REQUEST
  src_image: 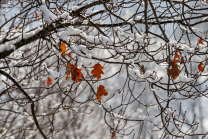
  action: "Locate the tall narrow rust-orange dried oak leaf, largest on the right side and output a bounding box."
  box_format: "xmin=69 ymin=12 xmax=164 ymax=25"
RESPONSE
xmin=167 ymin=50 xmax=181 ymax=79
